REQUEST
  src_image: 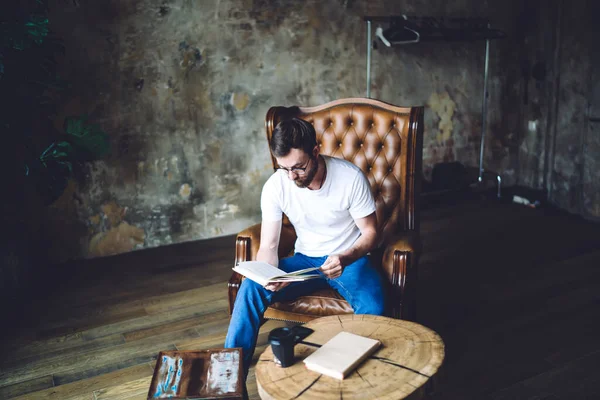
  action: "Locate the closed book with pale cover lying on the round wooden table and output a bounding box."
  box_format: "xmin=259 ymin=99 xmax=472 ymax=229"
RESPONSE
xmin=304 ymin=332 xmax=381 ymax=380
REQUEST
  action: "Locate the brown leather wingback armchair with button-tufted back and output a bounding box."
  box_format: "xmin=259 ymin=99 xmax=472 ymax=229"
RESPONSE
xmin=229 ymin=98 xmax=423 ymax=322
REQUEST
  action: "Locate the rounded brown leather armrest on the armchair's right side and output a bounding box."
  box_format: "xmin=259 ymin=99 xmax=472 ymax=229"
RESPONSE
xmin=381 ymin=231 xmax=422 ymax=321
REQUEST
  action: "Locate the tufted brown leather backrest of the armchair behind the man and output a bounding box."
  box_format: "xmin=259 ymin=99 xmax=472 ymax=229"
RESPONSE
xmin=266 ymin=98 xmax=423 ymax=245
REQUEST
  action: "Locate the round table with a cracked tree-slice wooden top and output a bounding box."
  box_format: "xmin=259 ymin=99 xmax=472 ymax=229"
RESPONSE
xmin=256 ymin=314 xmax=444 ymax=400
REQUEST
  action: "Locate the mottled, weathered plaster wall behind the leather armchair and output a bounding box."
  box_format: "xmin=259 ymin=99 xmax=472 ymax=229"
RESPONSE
xmin=38 ymin=0 xmax=596 ymax=259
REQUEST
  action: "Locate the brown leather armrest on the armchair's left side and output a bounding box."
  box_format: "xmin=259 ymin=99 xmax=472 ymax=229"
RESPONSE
xmin=227 ymin=220 xmax=296 ymax=315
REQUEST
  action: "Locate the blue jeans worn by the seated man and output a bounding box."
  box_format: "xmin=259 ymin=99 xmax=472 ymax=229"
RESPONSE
xmin=225 ymin=253 xmax=384 ymax=376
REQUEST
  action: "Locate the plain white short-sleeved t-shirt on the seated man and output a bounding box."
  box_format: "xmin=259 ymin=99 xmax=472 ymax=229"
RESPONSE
xmin=261 ymin=156 xmax=375 ymax=257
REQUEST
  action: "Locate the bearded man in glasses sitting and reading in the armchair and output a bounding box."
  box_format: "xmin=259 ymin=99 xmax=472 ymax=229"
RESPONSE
xmin=225 ymin=118 xmax=384 ymax=376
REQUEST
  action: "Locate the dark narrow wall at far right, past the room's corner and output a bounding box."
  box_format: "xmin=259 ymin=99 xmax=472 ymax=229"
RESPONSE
xmin=551 ymin=1 xmax=600 ymax=218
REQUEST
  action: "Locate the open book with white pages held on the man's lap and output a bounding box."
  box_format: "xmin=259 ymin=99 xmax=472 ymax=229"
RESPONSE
xmin=233 ymin=261 xmax=323 ymax=286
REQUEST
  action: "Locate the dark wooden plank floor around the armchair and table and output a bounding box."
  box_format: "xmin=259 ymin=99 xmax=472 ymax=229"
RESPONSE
xmin=0 ymin=200 xmax=600 ymax=400
